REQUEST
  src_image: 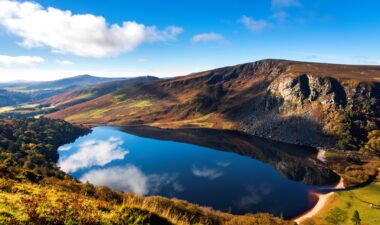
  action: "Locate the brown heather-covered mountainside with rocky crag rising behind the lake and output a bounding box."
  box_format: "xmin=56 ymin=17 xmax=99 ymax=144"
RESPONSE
xmin=47 ymin=60 xmax=380 ymax=148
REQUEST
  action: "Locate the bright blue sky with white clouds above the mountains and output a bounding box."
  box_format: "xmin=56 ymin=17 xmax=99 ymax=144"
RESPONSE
xmin=0 ymin=0 xmax=380 ymax=81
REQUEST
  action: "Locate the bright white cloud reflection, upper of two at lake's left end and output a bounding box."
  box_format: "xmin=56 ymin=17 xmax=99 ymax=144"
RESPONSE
xmin=59 ymin=137 xmax=128 ymax=173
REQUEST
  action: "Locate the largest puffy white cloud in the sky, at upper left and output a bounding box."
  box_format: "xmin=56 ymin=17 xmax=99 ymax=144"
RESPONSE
xmin=0 ymin=0 xmax=183 ymax=57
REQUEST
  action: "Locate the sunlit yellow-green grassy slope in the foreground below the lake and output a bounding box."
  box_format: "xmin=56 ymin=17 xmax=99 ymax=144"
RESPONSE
xmin=0 ymin=178 xmax=292 ymax=225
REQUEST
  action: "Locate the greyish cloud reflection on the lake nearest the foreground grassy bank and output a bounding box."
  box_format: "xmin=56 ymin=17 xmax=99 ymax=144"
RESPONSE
xmin=80 ymin=165 xmax=184 ymax=195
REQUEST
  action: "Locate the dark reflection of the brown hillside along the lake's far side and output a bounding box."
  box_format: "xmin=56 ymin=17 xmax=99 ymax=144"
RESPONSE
xmin=123 ymin=126 xmax=339 ymax=185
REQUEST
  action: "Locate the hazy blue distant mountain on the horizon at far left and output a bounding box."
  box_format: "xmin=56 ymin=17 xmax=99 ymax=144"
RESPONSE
xmin=0 ymin=75 xmax=125 ymax=106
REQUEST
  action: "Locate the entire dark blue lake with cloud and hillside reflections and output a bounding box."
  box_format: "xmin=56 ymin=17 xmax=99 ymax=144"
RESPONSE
xmin=59 ymin=127 xmax=337 ymax=218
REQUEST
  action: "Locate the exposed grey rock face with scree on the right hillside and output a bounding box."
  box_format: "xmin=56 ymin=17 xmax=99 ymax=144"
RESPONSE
xmin=240 ymin=69 xmax=379 ymax=147
